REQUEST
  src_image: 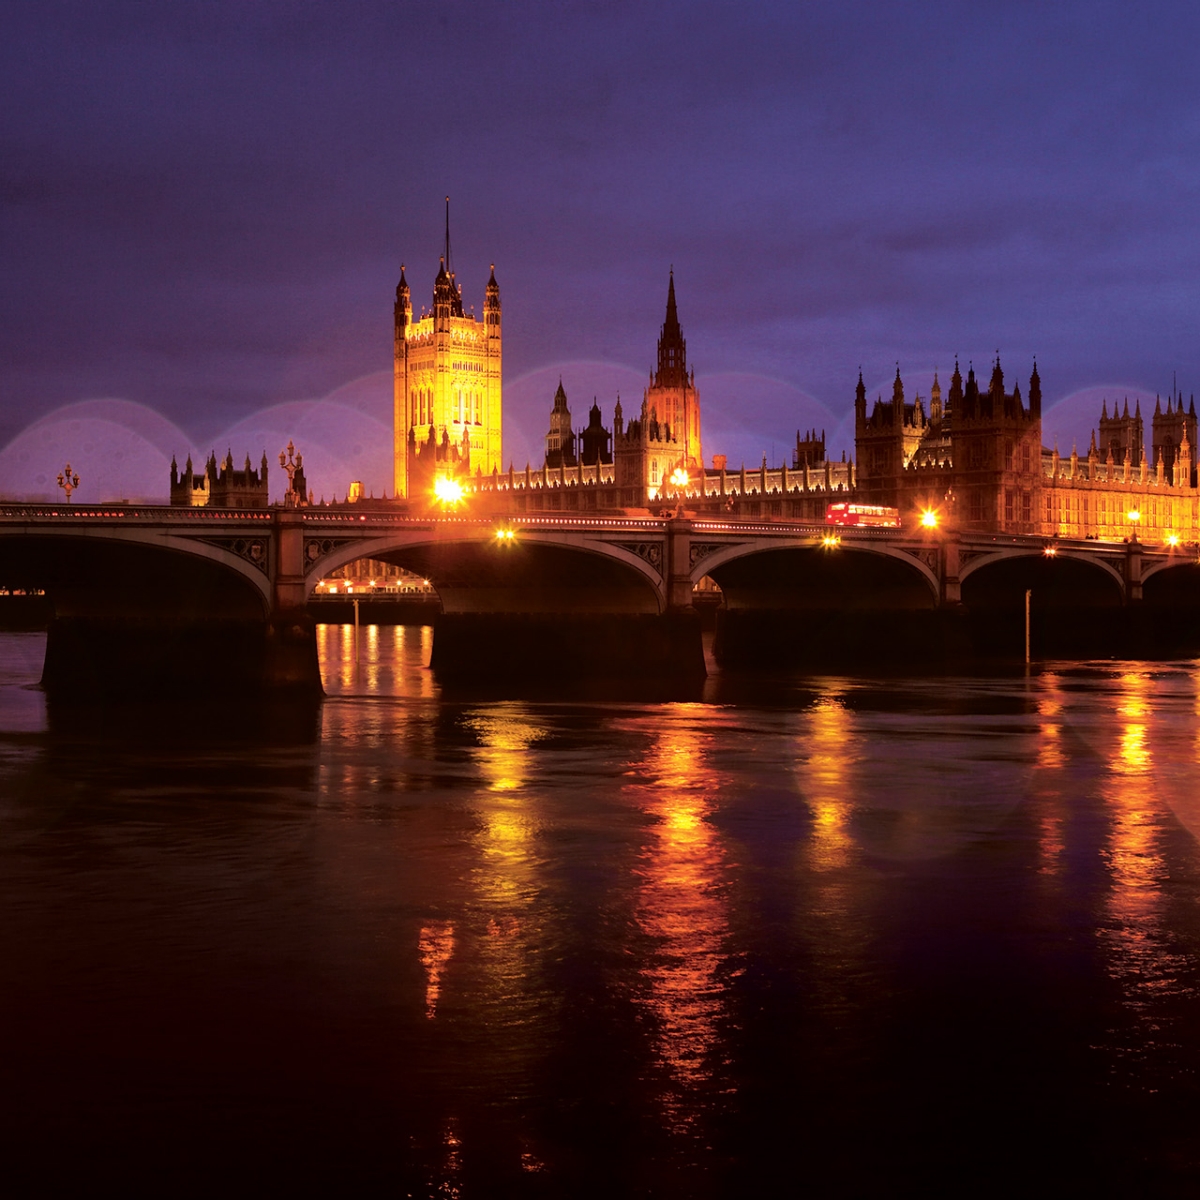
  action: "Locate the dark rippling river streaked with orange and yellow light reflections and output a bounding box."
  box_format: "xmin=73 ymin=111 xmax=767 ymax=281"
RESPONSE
xmin=0 ymin=626 xmax=1200 ymax=1198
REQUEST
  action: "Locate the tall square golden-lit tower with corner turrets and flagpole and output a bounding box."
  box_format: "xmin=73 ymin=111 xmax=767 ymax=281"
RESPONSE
xmin=392 ymin=210 xmax=502 ymax=497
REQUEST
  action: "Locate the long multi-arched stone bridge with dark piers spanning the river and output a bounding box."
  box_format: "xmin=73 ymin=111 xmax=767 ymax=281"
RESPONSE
xmin=0 ymin=504 xmax=1200 ymax=703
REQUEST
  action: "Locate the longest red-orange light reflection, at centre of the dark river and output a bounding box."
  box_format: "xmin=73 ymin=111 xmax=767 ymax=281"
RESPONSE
xmin=637 ymin=704 xmax=728 ymax=1132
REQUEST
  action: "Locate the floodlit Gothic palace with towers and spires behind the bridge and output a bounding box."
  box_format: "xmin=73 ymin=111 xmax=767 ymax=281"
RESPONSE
xmin=172 ymin=229 xmax=1200 ymax=544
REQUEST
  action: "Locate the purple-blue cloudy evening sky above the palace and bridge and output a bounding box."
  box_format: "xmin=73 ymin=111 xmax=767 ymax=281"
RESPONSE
xmin=0 ymin=0 xmax=1200 ymax=502
